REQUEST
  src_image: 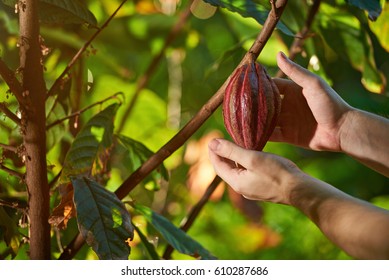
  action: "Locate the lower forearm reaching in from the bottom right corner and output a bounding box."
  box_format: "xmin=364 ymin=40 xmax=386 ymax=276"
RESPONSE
xmin=289 ymin=177 xmax=389 ymax=259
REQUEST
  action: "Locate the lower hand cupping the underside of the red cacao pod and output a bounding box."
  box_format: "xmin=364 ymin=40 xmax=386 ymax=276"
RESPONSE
xmin=208 ymin=139 xmax=307 ymax=204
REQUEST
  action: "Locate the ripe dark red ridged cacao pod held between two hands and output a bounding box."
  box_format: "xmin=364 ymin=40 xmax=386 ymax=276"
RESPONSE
xmin=223 ymin=61 xmax=281 ymax=151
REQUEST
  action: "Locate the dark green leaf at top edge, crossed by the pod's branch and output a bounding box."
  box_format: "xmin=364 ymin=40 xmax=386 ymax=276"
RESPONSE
xmin=204 ymin=0 xmax=294 ymax=36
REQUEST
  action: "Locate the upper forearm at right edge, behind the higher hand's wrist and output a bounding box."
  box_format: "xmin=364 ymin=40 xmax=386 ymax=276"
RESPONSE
xmin=340 ymin=110 xmax=389 ymax=177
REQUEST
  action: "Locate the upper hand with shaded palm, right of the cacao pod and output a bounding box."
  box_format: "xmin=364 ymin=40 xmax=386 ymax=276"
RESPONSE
xmin=270 ymin=52 xmax=352 ymax=151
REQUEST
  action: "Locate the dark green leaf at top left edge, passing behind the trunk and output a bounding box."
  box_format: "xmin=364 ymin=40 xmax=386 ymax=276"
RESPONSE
xmin=1 ymin=0 xmax=97 ymax=26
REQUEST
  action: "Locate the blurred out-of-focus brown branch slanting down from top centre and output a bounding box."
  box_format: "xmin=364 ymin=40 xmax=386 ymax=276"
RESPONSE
xmin=117 ymin=0 xmax=193 ymax=133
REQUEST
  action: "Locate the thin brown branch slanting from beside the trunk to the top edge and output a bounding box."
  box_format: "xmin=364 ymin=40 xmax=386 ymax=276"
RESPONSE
xmin=47 ymin=0 xmax=127 ymax=97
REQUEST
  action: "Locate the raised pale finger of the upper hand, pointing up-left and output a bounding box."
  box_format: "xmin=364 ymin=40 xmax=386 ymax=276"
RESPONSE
xmin=277 ymin=52 xmax=315 ymax=88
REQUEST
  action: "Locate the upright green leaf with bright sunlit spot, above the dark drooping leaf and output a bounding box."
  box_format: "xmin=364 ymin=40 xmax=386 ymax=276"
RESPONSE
xmin=59 ymin=104 xmax=119 ymax=184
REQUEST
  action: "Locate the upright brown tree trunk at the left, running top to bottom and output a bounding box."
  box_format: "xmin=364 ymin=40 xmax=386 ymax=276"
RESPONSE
xmin=18 ymin=0 xmax=50 ymax=259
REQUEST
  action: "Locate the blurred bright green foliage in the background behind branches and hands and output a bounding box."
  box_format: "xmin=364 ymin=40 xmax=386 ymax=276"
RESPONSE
xmin=0 ymin=0 xmax=389 ymax=259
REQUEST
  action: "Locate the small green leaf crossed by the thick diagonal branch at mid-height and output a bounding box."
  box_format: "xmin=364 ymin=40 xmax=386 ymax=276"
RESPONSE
xmin=117 ymin=135 xmax=169 ymax=189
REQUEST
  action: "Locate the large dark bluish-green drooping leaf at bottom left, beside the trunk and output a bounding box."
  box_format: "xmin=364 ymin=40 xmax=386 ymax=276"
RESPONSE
xmin=72 ymin=177 xmax=134 ymax=260
